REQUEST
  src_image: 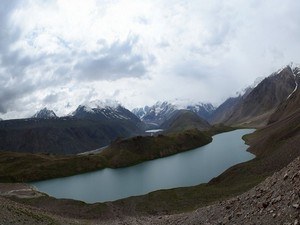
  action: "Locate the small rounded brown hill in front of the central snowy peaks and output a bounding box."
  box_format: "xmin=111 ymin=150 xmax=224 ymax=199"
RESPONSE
xmin=160 ymin=109 xmax=211 ymax=132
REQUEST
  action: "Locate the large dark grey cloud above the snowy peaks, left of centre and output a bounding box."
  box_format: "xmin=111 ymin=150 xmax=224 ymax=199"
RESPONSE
xmin=75 ymin=37 xmax=146 ymax=81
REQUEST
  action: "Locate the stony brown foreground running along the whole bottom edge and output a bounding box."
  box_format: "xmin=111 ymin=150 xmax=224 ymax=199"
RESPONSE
xmin=0 ymin=157 xmax=300 ymax=225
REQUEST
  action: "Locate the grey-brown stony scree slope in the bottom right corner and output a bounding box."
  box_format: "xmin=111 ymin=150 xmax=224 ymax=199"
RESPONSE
xmin=132 ymin=157 xmax=300 ymax=225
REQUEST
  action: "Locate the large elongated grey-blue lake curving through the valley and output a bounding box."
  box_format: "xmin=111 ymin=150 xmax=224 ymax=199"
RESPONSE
xmin=31 ymin=129 xmax=255 ymax=203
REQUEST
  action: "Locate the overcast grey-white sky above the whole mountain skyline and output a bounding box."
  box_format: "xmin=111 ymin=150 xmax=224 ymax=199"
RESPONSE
xmin=0 ymin=0 xmax=300 ymax=119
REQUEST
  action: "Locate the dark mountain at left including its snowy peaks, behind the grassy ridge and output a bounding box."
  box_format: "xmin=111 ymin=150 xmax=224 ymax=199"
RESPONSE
xmin=0 ymin=102 xmax=144 ymax=154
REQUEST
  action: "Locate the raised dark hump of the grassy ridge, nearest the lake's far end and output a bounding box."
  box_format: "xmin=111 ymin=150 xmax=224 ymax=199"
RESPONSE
xmin=101 ymin=129 xmax=212 ymax=168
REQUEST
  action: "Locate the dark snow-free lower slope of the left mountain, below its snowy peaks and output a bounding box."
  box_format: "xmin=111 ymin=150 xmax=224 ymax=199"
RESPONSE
xmin=0 ymin=117 xmax=143 ymax=154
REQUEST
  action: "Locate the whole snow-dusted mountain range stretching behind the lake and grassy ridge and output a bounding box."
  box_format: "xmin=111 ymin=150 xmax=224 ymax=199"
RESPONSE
xmin=0 ymin=65 xmax=300 ymax=154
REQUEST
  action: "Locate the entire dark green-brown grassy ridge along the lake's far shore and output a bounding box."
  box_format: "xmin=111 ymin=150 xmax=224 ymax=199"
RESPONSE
xmin=0 ymin=130 xmax=212 ymax=182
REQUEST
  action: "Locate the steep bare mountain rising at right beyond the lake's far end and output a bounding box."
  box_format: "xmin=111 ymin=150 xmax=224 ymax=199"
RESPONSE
xmin=211 ymin=65 xmax=299 ymax=126
